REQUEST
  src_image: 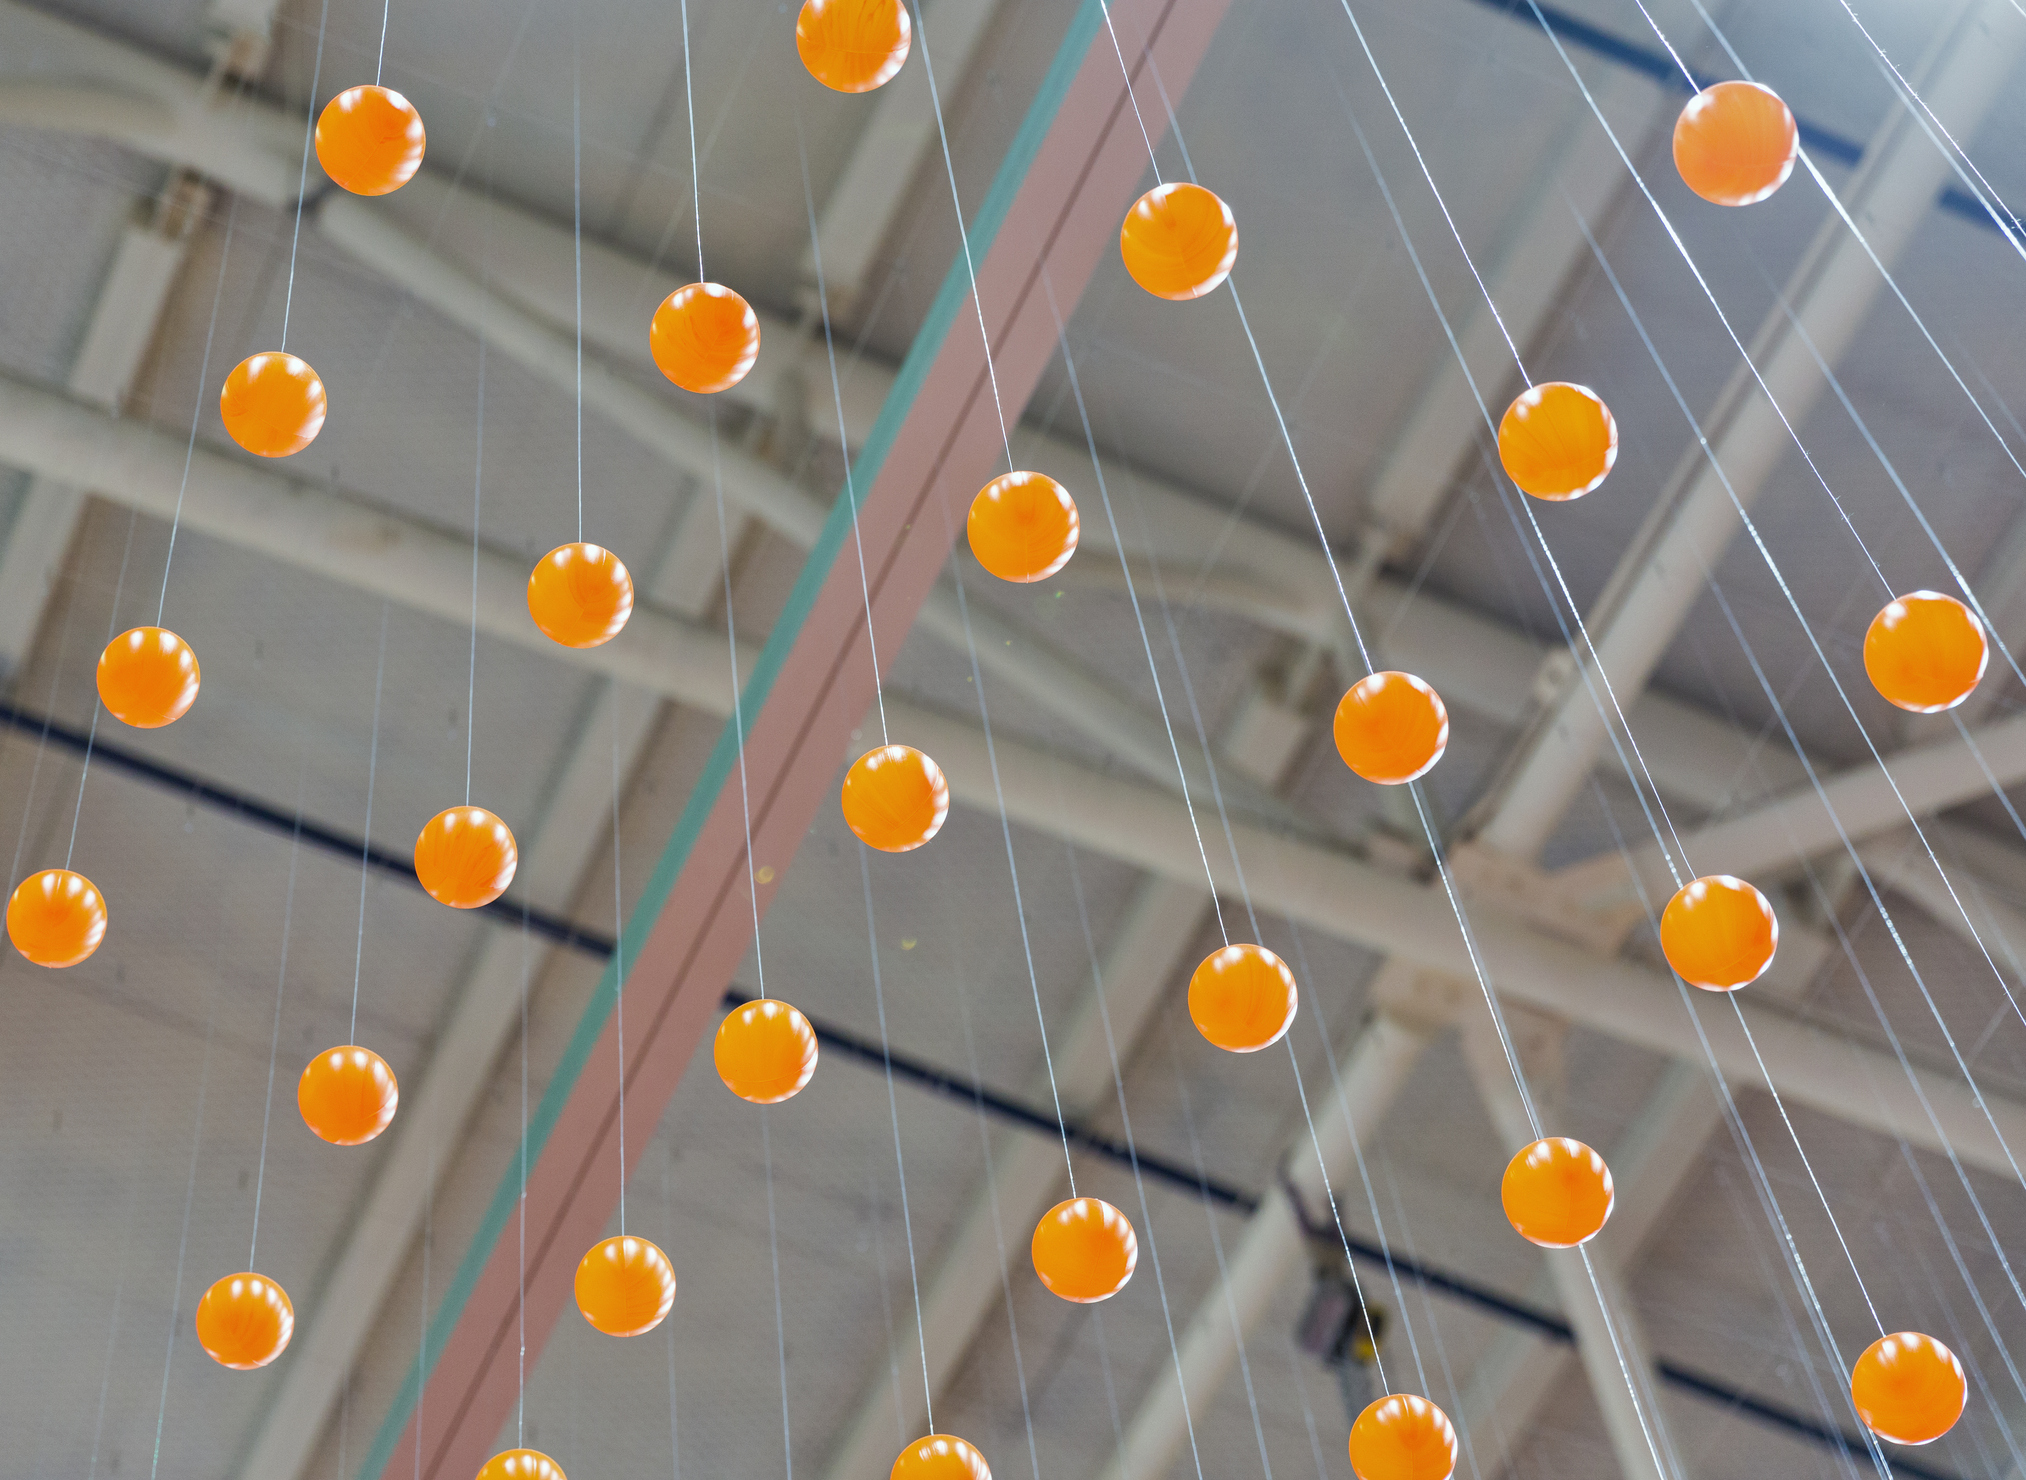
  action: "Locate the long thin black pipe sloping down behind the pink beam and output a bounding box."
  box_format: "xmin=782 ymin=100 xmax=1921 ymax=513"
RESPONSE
xmin=0 ymin=705 xmax=1957 ymax=1480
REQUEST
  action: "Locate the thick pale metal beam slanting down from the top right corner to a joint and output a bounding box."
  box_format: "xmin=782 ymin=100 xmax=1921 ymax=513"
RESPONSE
xmin=1479 ymin=0 xmax=2026 ymax=867
